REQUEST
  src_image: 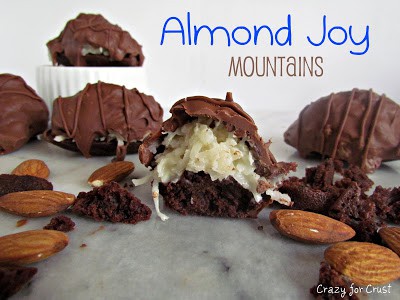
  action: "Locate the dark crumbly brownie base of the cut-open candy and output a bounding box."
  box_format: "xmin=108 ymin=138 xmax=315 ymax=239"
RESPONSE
xmin=159 ymin=171 xmax=269 ymax=218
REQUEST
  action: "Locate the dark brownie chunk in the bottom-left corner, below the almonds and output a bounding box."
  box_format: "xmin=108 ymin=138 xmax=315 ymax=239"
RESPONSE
xmin=0 ymin=266 xmax=37 ymax=299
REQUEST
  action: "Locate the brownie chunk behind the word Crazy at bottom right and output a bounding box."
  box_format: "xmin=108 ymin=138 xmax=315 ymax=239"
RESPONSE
xmin=310 ymin=262 xmax=359 ymax=300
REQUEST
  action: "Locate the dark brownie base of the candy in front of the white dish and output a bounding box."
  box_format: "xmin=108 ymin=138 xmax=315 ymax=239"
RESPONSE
xmin=43 ymin=130 xmax=142 ymax=156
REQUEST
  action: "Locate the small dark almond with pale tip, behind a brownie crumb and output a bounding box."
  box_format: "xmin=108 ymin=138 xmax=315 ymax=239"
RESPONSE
xmin=88 ymin=161 xmax=135 ymax=187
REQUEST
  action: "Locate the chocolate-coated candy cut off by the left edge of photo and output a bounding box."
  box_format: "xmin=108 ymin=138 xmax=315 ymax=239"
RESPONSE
xmin=0 ymin=74 xmax=49 ymax=155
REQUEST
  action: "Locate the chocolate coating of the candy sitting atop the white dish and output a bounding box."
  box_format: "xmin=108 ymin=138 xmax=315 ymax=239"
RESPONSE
xmin=47 ymin=13 xmax=144 ymax=67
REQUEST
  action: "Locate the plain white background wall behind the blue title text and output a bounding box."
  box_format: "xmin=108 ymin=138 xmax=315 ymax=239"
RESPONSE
xmin=0 ymin=0 xmax=400 ymax=111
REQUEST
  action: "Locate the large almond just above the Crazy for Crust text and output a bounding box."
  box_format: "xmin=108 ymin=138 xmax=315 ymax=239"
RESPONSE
xmin=324 ymin=242 xmax=400 ymax=285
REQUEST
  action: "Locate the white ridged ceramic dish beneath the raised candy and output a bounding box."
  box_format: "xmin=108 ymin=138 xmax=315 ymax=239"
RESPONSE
xmin=36 ymin=66 xmax=149 ymax=111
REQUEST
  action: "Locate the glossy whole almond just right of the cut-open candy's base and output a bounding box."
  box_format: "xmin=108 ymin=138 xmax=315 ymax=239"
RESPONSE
xmin=269 ymin=209 xmax=355 ymax=244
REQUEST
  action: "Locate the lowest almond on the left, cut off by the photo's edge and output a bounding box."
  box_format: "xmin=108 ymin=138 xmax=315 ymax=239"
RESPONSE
xmin=0 ymin=230 xmax=68 ymax=265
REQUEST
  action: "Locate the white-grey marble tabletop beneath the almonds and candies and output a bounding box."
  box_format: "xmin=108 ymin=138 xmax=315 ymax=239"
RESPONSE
xmin=0 ymin=111 xmax=400 ymax=299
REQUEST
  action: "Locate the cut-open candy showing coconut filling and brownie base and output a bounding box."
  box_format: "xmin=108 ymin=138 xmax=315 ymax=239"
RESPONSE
xmin=139 ymin=93 xmax=295 ymax=219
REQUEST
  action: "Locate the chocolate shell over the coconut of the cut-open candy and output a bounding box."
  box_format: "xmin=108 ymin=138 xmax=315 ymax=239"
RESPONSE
xmin=139 ymin=93 xmax=296 ymax=178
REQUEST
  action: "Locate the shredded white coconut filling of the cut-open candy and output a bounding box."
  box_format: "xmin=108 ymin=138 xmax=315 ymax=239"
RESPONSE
xmin=133 ymin=118 xmax=291 ymax=220
